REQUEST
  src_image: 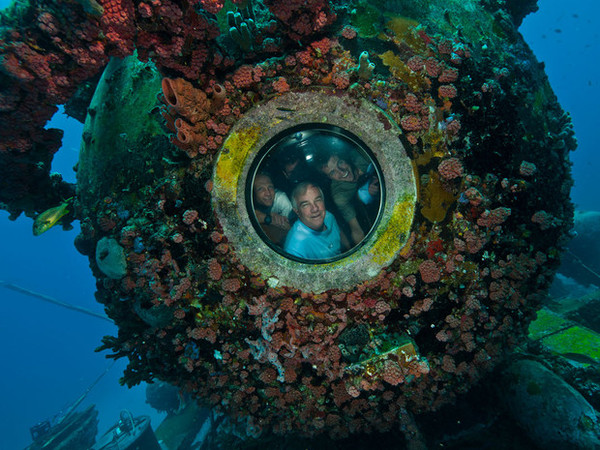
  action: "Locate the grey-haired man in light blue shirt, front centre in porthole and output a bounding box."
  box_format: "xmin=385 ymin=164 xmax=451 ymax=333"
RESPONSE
xmin=283 ymin=182 xmax=348 ymax=260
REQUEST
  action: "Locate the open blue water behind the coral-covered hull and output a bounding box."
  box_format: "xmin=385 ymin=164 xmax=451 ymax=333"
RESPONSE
xmin=0 ymin=0 xmax=600 ymax=449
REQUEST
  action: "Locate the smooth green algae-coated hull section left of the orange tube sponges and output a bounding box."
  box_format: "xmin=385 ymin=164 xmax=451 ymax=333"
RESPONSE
xmin=77 ymin=56 xmax=168 ymax=214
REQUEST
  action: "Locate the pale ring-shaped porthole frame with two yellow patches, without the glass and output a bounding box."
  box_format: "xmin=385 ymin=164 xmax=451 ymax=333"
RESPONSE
xmin=212 ymin=91 xmax=417 ymax=293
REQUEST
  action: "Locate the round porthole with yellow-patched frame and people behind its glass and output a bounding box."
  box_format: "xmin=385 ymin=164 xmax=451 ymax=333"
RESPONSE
xmin=212 ymin=91 xmax=417 ymax=292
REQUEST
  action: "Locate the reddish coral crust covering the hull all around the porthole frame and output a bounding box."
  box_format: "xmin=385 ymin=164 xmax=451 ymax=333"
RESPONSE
xmin=0 ymin=0 xmax=575 ymax=437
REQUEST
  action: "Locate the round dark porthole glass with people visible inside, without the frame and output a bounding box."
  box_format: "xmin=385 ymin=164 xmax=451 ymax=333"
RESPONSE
xmin=246 ymin=124 xmax=385 ymax=264
